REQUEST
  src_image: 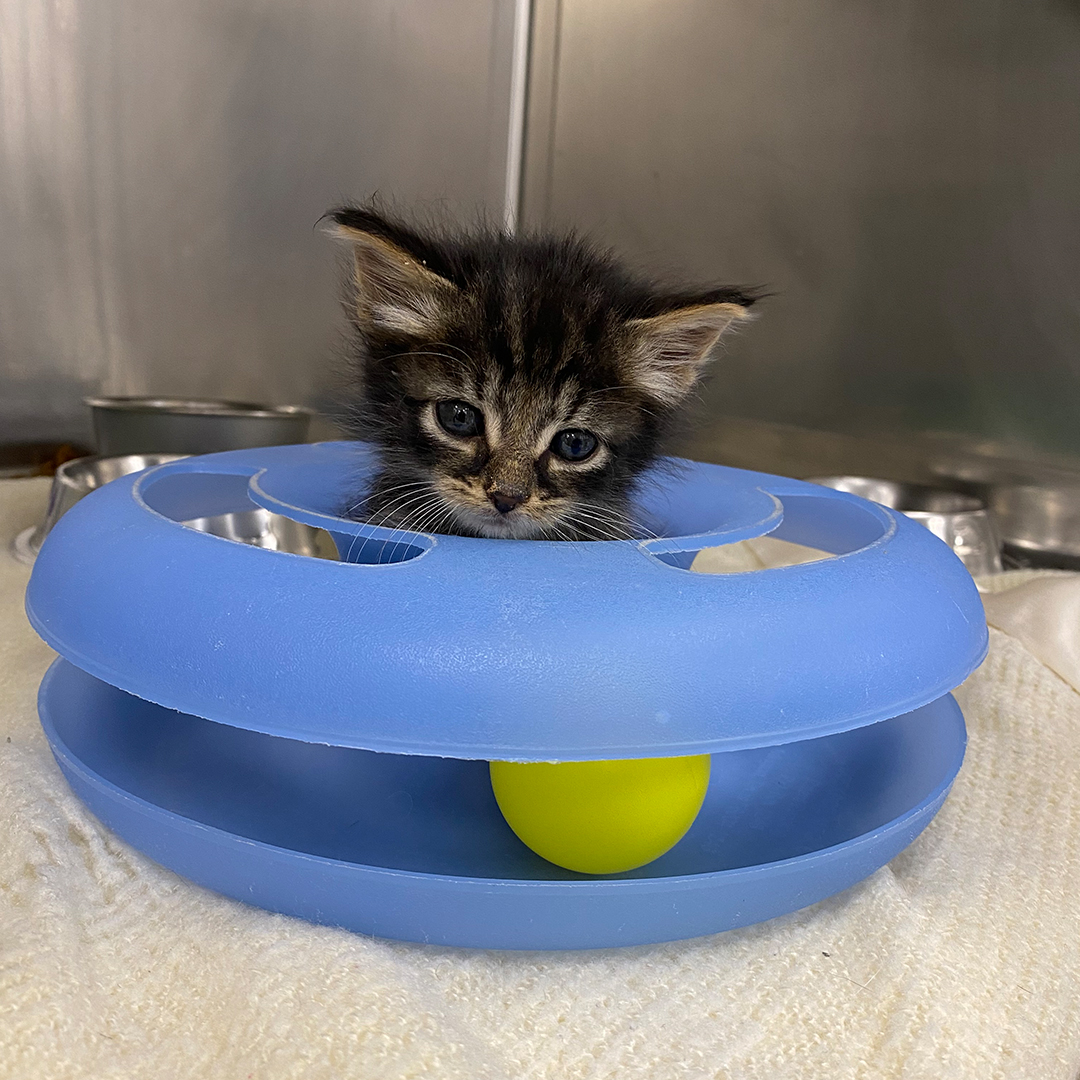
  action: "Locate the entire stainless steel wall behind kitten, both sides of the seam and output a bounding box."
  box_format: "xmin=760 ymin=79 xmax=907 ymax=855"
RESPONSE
xmin=10 ymin=0 xmax=1080 ymax=466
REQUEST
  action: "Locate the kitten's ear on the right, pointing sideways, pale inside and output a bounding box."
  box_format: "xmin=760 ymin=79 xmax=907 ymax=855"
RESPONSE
xmin=626 ymin=301 xmax=752 ymax=405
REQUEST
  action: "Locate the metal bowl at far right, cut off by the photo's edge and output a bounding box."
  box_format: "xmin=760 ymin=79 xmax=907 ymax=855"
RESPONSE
xmin=989 ymin=484 xmax=1080 ymax=570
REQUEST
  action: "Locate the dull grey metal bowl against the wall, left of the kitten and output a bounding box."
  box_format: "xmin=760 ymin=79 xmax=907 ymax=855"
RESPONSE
xmin=86 ymin=397 xmax=315 ymax=457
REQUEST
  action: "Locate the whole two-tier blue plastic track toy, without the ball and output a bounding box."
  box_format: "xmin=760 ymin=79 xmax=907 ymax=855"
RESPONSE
xmin=27 ymin=443 xmax=987 ymax=949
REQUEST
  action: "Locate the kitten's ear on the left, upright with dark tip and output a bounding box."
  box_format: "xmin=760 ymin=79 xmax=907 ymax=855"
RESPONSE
xmin=328 ymin=210 xmax=460 ymax=338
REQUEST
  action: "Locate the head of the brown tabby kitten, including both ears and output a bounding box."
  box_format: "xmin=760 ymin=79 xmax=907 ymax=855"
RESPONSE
xmin=330 ymin=207 xmax=754 ymax=540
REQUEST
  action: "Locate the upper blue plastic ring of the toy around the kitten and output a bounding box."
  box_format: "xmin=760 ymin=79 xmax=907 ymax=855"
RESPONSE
xmin=27 ymin=443 xmax=987 ymax=760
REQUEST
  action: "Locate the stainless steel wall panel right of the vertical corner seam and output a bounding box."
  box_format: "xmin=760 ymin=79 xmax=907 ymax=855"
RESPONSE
xmin=525 ymin=0 xmax=1080 ymax=464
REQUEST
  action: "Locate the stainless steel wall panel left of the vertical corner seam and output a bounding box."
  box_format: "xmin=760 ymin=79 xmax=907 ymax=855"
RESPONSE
xmin=0 ymin=0 xmax=514 ymax=442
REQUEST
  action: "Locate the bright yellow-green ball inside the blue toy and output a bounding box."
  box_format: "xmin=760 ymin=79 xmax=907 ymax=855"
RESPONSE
xmin=490 ymin=754 xmax=711 ymax=874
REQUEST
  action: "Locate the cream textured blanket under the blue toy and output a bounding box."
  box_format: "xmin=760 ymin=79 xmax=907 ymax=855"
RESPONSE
xmin=0 ymin=481 xmax=1080 ymax=1080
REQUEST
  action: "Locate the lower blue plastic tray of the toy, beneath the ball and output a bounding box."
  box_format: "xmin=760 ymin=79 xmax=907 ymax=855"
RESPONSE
xmin=39 ymin=660 xmax=966 ymax=949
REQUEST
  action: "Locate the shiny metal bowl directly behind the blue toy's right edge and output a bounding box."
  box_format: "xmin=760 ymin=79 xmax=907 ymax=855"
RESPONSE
xmin=811 ymin=476 xmax=1001 ymax=577
